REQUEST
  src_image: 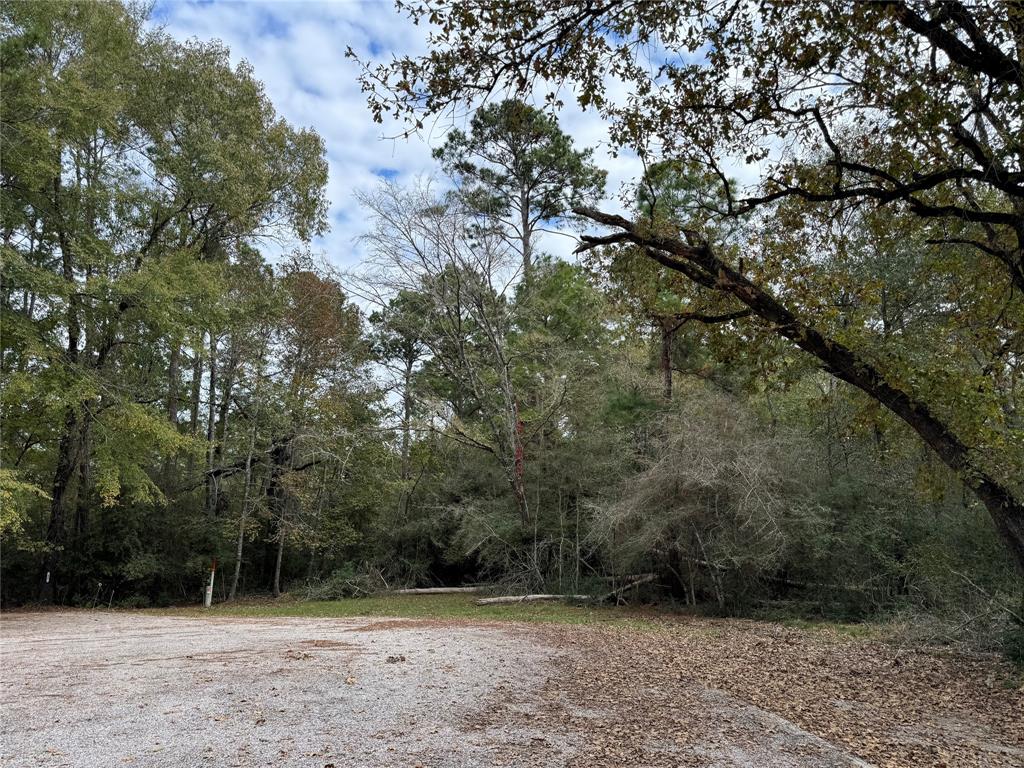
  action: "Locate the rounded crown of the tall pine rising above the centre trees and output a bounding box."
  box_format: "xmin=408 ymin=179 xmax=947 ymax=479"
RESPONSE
xmin=434 ymin=99 xmax=605 ymax=281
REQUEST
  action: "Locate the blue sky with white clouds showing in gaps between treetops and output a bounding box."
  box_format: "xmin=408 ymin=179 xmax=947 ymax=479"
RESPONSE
xmin=153 ymin=0 xmax=641 ymax=269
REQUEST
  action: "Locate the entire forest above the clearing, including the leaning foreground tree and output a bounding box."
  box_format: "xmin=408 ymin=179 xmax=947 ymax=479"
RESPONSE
xmin=0 ymin=0 xmax=1024 ymax=657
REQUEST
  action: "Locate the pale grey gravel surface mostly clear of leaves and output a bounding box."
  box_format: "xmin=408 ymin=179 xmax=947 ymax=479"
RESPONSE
xmin=0 ymin=611 xmax=863 ymax=768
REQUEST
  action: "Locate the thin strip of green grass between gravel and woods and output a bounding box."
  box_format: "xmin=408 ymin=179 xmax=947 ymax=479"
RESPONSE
xmin=159 ymin=595 xmax=655 ymax=627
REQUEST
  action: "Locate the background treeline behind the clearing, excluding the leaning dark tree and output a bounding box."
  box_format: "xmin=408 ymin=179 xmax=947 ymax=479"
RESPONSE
xmin=0 ymin=3 xmax=1022 ymax=651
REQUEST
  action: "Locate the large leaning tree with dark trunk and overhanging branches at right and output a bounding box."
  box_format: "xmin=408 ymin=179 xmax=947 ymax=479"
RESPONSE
xmin=354 ymin=0 xmax=1024 ymax=571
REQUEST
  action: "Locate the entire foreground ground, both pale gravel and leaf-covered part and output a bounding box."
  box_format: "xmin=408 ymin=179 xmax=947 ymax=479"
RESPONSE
xmin=0 ymin=611 xmax=1024 ymax=768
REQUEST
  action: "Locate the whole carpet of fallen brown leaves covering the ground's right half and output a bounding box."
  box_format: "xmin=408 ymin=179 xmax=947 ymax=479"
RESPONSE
xmin=476 ymin=620 xmax=1024 ymax=768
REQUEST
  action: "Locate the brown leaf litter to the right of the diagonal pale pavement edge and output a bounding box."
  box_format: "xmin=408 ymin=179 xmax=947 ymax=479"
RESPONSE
xmin=657 ymin=622 xmax=1024 ymax=768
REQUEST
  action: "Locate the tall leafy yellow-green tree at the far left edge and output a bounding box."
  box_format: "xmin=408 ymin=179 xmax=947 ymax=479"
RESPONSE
xmin=0 ymin=3 xmax=327 ymax=595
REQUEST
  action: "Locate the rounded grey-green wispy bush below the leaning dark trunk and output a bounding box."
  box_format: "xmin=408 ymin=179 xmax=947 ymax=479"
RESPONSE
xmin=595 ymin=392 xmax=804 ymax=610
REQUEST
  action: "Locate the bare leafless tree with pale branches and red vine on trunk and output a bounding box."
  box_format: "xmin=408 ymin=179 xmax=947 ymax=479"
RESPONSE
xmin=360 ymin=182 xmax=530 ymax=524
